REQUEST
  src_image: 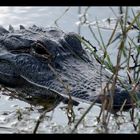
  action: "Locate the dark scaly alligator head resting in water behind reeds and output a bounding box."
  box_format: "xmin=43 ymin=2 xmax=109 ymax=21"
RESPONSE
xmin=0 ymin=25 xmax=140 ymax=110
